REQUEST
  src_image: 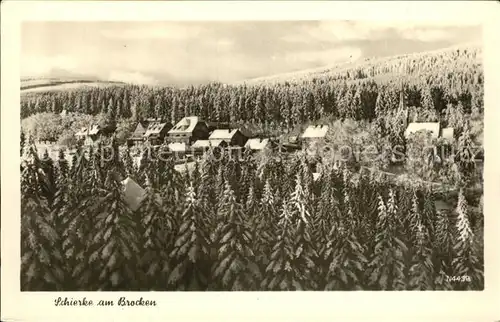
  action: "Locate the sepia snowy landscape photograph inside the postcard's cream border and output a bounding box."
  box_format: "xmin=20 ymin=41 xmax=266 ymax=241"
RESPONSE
xmin=19 ymin=20 xmax=485 ymax=291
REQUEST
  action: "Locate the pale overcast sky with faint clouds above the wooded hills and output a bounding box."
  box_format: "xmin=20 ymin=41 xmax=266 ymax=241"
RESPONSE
xmin=21 ymin=21 xmax=482 ymax=84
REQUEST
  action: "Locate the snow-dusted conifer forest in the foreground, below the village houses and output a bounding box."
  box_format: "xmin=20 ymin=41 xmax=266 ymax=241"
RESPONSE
xmin=21 ymin=135 xmax=484 ymax=291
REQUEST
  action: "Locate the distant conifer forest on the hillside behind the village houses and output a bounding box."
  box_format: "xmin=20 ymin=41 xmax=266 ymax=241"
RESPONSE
xmin=21 ymin=48 xmax=483 ymax=135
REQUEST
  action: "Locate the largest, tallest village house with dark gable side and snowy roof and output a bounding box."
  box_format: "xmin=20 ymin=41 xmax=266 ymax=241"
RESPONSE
xmin=167 ymin=116 xmax=209 ymax=145
